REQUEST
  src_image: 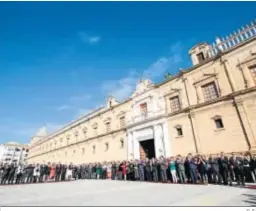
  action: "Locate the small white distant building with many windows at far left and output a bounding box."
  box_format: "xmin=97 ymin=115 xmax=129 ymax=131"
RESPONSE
xmin=0 ymin=142 xmax=29 ymax=164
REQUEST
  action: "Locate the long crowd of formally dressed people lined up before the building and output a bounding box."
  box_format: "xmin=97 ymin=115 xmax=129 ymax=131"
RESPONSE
xmin=0 ymin=153 xmax=256 ymax=185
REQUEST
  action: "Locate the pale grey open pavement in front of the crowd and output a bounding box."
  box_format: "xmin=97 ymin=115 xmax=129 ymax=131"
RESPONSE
xmin=0 ymin=180 xmax=256 ymax=206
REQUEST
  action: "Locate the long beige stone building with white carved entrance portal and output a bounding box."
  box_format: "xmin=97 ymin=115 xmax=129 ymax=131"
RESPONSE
xmin=28 ymin=21 xmax=256 ymax=164
